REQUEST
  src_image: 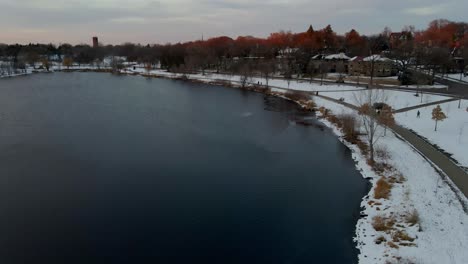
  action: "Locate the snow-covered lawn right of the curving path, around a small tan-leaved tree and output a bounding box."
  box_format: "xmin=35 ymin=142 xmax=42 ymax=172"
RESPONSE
xmin=395 ymin=100 xmax=468 ymax=167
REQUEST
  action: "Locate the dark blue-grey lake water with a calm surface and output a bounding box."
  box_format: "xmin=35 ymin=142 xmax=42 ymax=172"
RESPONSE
xmin=0 ymin=73 xmax=367 ymax=264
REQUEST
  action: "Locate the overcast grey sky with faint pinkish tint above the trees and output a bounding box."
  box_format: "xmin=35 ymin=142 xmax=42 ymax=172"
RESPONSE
xmin=0 ymin=0 xmax=468 ymax=44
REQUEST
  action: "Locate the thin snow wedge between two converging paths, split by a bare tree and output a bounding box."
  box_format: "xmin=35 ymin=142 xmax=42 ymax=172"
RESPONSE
xmin=322 ymin=90 xmax=450 ymax=110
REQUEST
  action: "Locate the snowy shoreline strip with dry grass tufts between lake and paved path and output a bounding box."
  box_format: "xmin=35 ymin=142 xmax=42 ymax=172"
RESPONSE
xmin=314 ymin=98 xmax=468 ymax=264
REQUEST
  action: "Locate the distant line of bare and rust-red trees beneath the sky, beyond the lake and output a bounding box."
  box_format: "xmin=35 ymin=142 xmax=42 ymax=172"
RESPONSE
xmin=0 ymin=19 xmax=468 ymax=77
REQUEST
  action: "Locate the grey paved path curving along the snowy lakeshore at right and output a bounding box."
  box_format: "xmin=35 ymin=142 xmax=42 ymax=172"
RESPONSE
xmin=318 ymin=95 xmax=468 ymax=200
